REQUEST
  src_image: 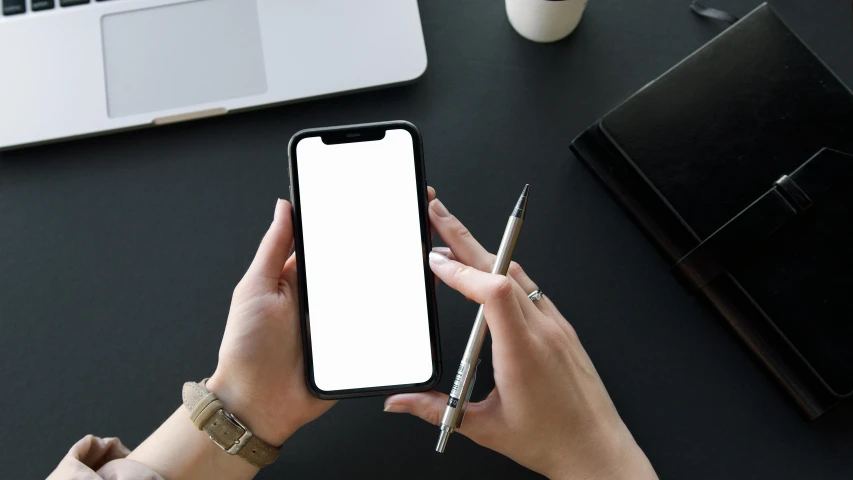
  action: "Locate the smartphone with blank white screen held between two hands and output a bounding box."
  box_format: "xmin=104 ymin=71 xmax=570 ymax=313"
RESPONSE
xmin=288 ymin=121 xmax=441 ymax=399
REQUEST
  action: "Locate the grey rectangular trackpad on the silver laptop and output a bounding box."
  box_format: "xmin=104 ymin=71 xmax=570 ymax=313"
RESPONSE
xmin=101 ymin=0 xmax=267 ymax=118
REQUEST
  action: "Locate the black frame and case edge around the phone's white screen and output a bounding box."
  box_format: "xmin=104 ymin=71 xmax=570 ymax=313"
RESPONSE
xmin=287 ymin=120 xmax=442 ymax=400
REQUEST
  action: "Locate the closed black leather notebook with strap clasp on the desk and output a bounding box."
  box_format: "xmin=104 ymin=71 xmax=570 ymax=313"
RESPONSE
xmin=572 ymin=4 xmax=853 ymax=418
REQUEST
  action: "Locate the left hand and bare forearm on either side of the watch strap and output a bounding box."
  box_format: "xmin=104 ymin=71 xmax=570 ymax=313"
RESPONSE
xmin=128 ymin=200 xmax=334 ymax=479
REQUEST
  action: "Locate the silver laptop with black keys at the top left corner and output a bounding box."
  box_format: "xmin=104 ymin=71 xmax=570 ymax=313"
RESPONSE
xmin=0 ymin=0 xmax=427 ymax=150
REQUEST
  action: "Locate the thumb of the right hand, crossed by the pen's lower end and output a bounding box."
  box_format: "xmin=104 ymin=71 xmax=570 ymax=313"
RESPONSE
xmin=385 ymin=390 xmax=496 ymax=446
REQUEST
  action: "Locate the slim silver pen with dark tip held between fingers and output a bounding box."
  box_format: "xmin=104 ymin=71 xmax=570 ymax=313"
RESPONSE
xmin=435 ymin=185 xmax=530 ymax=453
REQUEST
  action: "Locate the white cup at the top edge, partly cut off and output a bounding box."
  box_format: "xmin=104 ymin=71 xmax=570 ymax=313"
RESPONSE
xmin=506 ymin=0 xmax=587 ymax=43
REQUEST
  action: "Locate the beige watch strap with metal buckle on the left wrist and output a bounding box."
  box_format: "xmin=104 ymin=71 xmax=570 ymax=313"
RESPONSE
xmin=181 ymin=379 xmax=281 ymax=467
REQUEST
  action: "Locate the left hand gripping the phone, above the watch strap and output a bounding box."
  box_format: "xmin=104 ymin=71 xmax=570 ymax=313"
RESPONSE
xmin=207 ymin=188 xmax=435 ymax=445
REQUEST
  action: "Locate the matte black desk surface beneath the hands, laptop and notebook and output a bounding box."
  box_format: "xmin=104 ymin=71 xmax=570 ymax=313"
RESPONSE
xmin=0 ymin=0 xmax=853 ymax=479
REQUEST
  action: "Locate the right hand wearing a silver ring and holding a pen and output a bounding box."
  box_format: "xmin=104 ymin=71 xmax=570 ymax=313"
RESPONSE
xmin=385 ymin=200 xmax=657 ymax=479
